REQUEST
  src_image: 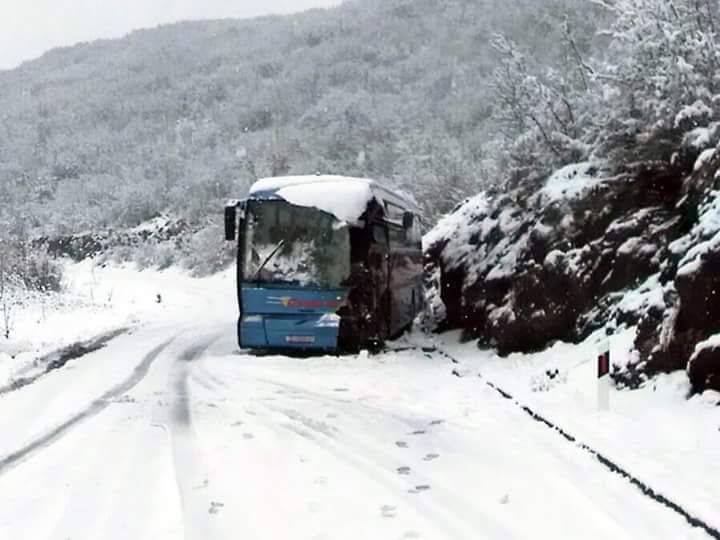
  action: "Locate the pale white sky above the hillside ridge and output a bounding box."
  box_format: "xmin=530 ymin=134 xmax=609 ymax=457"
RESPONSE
xmin=0 ymin=0 xmax=340 ymax=69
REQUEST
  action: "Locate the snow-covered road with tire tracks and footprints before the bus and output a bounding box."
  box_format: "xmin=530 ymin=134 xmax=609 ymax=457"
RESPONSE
xmin=0 ymin=314 xmax=707 ymax=540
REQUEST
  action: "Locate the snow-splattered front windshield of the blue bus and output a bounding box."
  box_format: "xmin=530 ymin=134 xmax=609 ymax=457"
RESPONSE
xmin=244 ymin=201 xmax=350 ymax=288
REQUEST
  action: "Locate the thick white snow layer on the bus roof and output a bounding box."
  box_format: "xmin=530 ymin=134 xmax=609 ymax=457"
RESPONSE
xmin=250 ymin=175 xmax=415 ymax=223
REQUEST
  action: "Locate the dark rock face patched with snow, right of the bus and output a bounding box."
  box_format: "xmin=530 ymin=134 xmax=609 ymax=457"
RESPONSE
xmin=425 ymin=136 xmax=720 ymax=390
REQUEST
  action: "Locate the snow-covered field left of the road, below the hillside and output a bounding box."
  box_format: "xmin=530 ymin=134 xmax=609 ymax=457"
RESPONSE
xmin=0 ymin=260 xmax=234 ymax=388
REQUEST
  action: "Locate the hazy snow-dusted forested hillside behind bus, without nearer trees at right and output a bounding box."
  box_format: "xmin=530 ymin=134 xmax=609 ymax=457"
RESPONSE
xmin=0 ymin=0 xmax=609 ymax=233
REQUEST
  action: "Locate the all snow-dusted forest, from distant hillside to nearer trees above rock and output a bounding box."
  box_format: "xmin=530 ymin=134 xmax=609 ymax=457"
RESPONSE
xmin=0 ymin=0 xmax=720 ymax=276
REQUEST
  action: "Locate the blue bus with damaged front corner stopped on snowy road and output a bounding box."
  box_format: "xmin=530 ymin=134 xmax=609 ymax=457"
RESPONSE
xmin=225 ymin=176 xmax=424 ymax=352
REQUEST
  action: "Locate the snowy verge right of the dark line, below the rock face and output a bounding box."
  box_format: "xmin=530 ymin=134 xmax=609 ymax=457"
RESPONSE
xmin=445 ymin=329 xmax=720 ymax=528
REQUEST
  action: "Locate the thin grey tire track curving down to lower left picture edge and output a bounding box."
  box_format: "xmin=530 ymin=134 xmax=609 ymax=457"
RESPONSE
xmin=0 ymin=337 xmax=175 ymax=476
